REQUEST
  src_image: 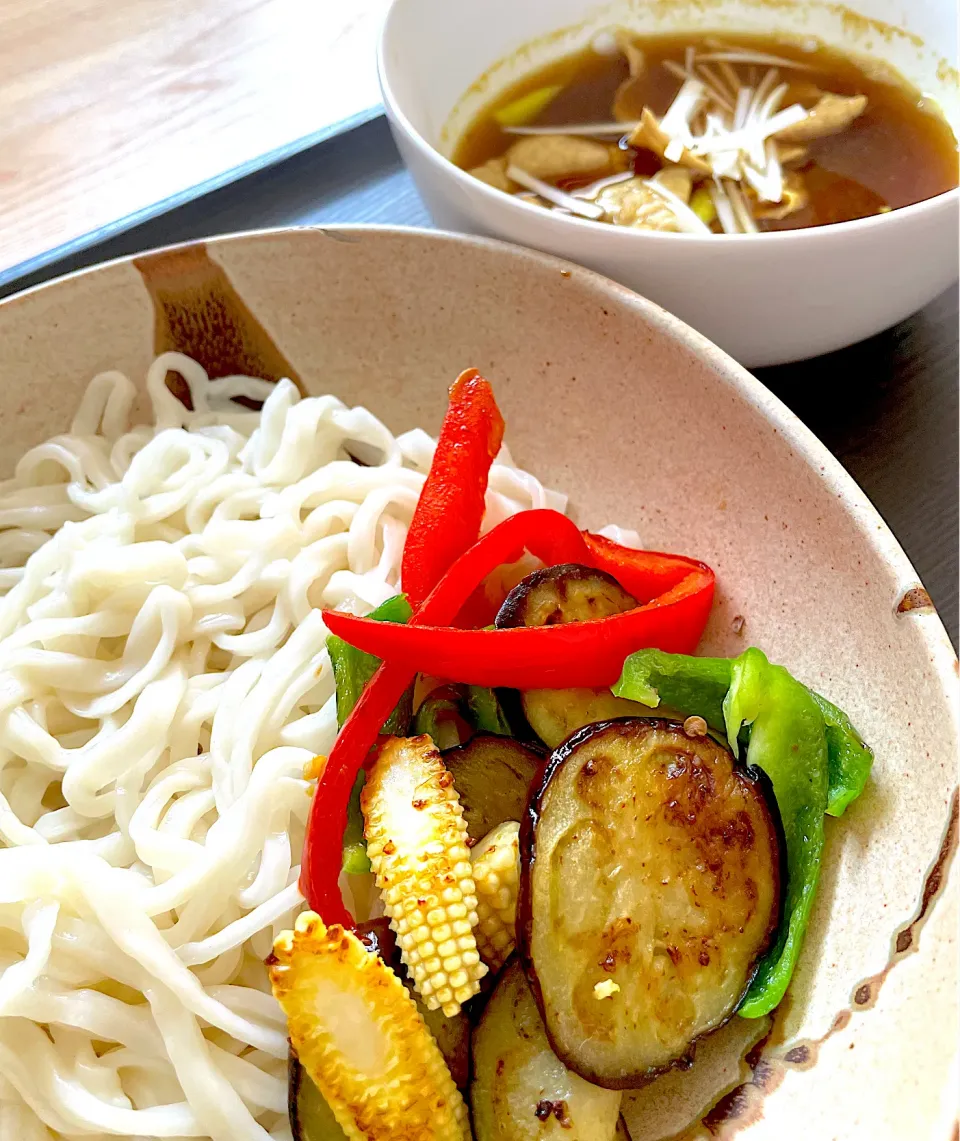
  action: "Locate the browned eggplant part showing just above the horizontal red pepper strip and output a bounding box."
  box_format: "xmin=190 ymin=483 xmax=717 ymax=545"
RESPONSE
xmin=497 ymin=563 xmax=637 ymax=629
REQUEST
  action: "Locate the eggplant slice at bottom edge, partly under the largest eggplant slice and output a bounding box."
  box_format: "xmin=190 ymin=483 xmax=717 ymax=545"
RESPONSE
xmin=470 ymin=958 xmax=621 ymax=1141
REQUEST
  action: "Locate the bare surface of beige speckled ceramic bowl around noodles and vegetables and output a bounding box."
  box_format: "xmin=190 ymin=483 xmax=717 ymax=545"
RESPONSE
xmin=0 ymin=228 xmax=958 ymax=1141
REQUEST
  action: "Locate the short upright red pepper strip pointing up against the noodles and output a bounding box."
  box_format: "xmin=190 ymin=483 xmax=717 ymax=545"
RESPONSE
xmin=400 ymin=369 xmax=503 ymax=610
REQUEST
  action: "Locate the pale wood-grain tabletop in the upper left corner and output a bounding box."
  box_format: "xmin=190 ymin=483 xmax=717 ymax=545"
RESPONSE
xmin=0 ymin=0 xmax=387 ymax=281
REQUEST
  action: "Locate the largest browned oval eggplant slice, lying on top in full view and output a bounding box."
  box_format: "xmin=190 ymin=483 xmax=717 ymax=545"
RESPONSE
xmin=517 ymin=718 xmax=781 ymax=1089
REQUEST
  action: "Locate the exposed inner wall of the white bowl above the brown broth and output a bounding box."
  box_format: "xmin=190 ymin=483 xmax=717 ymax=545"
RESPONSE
xmin=382 ymin=0 xmax=960 ymax=157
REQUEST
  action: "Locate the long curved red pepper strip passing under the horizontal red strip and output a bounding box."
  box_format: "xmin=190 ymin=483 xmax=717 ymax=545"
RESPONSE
xmin=300 ymin=509 xmax=589 ymax=928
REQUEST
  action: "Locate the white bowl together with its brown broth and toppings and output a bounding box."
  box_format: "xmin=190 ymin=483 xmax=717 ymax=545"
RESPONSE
xmin=380 ymin=0 xmax=960 ymax=366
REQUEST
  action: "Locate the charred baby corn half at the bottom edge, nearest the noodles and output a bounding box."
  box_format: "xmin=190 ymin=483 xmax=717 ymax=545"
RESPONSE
xmin=268 ymin=912 xmax=469 ymax=1141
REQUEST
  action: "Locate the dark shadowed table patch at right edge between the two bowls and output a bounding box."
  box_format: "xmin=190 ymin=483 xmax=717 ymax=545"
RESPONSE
xmin=757 ymin=289 xmax=960 ymax=646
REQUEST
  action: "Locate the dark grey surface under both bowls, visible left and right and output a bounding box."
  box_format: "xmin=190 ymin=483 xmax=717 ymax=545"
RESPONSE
xmin=0 ymin=119 xmax=958 ymax=646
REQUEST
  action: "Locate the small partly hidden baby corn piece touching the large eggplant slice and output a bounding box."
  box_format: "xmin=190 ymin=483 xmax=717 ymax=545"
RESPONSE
xmin=470 ymin=820 xmax=521 ymax=971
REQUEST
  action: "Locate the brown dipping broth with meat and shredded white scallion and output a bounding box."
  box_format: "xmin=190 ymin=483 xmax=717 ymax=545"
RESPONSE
xmin=453 ymin=31 xmax=958 ymax=234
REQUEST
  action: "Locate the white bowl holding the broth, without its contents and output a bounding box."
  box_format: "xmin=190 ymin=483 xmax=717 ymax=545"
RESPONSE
xmin=379 ymin=0 xmax=960 ymax=367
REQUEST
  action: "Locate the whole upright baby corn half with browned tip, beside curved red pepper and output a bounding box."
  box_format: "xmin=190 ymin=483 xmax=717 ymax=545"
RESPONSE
xmin=361 ymin=736 xmax=486 ymax=1017
